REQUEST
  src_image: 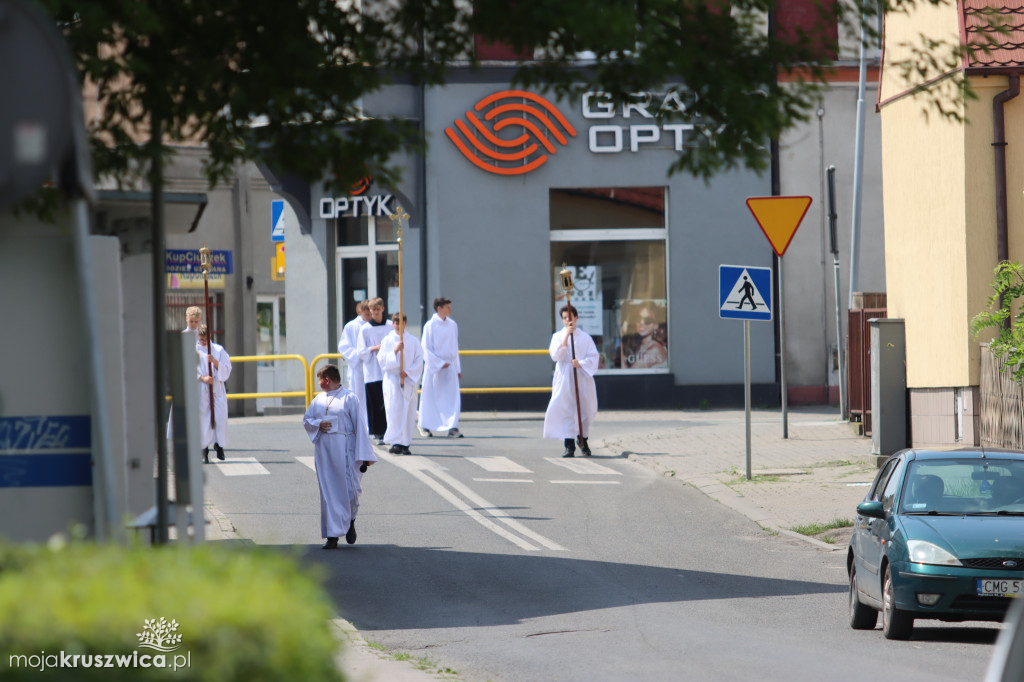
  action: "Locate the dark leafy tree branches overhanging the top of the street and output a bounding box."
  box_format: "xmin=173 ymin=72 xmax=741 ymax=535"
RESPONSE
xmin=40 ymin=0 xmax=966 ymax=187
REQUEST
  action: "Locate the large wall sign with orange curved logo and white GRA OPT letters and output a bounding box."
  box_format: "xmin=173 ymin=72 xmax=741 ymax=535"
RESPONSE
xmin=444 ymin=90 xmax=710 ymax=175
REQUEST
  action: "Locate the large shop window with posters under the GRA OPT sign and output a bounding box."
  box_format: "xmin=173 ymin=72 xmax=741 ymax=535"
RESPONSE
xmin=549 ymin=187 xmax=669 ymax=372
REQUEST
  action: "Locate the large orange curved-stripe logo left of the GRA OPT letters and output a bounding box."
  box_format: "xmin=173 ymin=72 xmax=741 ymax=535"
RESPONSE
xmin=444 ymin=90 xmax=575 ymax=175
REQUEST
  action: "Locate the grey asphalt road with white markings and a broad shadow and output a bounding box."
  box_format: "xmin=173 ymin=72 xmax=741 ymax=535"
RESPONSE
xmin=206 ymin=418 xmax=997 ymax=682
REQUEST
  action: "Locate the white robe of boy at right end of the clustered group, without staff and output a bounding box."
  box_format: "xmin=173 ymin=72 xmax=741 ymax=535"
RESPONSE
xmin=420 ymin=313 xmax=462 ymax=431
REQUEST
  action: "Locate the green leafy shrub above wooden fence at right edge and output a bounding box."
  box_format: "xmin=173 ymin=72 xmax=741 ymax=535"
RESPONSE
xmin=971 ymin=260 xmax=1024 ymax=382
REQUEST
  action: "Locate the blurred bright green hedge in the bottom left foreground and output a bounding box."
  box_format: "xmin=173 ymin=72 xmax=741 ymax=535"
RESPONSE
xmin=0 ymin=543 xmax=342 ymax=682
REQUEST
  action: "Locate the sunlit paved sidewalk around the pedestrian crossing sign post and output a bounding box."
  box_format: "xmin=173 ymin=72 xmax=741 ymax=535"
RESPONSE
xmin=595 ymin=406 xmax=877 ymax=550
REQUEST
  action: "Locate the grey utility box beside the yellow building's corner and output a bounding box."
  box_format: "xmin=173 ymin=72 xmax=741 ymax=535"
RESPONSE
xmin=867 ymin=318 xmax=906 ymax=461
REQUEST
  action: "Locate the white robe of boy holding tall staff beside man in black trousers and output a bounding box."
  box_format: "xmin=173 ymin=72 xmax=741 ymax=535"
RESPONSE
xmin=377 ymin=330 xmax=423 ymax=445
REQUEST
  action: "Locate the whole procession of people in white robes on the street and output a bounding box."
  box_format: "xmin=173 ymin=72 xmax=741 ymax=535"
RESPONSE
xmin=183 ymin=270 xmax=600 ymax=549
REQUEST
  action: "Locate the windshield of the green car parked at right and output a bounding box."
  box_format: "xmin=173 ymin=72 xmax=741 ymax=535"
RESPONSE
xmin=900 ymin=459 xmax=1024 ymax=514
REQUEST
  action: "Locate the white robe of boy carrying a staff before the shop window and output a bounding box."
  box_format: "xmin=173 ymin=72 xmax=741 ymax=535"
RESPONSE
xmin=544 ymin=328 xmax=601 ymax=439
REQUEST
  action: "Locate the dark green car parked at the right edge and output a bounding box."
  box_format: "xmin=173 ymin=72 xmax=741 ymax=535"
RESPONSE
xmin=847 ymin=449 xmax=1024 ymax=639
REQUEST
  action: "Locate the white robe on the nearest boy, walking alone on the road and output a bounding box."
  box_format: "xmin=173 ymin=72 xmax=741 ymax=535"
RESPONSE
xmin=302 ymin=386 xmax=377 ymax=538
